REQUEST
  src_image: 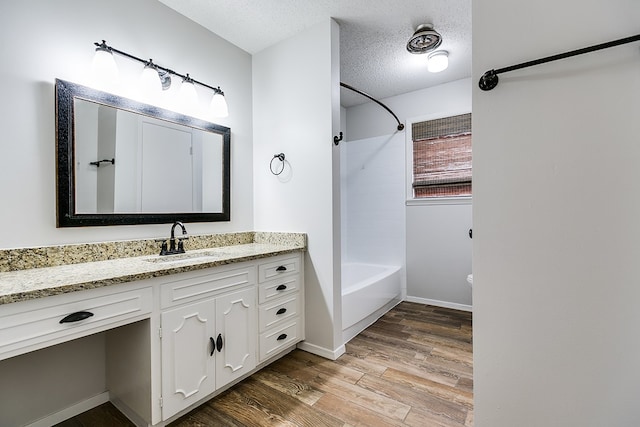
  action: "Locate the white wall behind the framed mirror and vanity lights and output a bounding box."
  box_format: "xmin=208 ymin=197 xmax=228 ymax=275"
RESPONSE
xmin=0 ymin=0 xmax=253 ymax=248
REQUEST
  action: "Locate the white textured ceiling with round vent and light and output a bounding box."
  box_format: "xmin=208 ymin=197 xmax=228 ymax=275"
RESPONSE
xmin=159 ymin=0 xmax=471 ymax=107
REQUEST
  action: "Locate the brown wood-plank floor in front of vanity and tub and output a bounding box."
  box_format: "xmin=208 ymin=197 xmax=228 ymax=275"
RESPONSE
xmin=59 ymin=302 xmax=473 ymax=427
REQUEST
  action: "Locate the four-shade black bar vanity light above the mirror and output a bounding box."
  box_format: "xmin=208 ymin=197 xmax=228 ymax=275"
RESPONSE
xmin=93 ymin=40 xmax=229 ymax=117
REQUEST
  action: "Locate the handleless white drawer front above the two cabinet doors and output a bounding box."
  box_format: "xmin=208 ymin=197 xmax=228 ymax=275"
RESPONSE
xmin=160 ymin=266 xmax=256 ymax=308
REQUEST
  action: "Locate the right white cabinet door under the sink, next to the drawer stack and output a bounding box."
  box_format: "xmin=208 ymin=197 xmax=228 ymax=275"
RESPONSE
xmin=216 ymin=288 xmax=257 ymax=387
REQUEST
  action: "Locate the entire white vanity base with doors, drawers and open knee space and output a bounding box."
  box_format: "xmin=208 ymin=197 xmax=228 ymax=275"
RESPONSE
xmin=0 ymin=252 xmax=304 ymax=427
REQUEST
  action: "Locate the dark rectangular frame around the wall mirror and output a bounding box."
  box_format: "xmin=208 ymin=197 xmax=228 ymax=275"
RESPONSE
xmin=55 ymin=79 xmax=231 ymax=227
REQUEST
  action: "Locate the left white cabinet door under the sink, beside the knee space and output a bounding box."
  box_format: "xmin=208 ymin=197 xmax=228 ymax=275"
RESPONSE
xmin=161 ymin=299 xmax=216 ymax=420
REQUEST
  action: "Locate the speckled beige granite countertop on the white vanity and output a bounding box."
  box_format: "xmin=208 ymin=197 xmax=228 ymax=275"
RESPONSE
xmin=0 ymin=243 xmax=306 ymax=305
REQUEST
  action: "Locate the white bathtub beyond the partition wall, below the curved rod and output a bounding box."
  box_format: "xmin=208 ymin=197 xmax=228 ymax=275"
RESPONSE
xmin=342 ymin=263 xmax=402 ymax=343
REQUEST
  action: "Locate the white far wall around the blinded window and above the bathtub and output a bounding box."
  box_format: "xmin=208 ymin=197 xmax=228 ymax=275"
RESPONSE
xmin=343 ymin=79 xmax=471 ymax=309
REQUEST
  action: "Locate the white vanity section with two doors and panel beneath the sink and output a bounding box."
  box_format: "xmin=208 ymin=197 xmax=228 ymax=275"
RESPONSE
xmin=160 ymin=264 xmax=256 ymax=420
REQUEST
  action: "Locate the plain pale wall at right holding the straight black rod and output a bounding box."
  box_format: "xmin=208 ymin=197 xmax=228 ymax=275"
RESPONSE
xmin=473 ymin=0 xmax=640 ymax=427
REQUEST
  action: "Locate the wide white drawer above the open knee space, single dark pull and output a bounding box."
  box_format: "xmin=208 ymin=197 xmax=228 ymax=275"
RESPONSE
xmin=0 ymin=288 xmax=153 ymax=359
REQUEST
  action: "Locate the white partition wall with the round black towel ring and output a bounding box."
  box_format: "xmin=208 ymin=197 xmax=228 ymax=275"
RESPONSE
xmin=253 ymin=20 xmax=342 ymax=357
